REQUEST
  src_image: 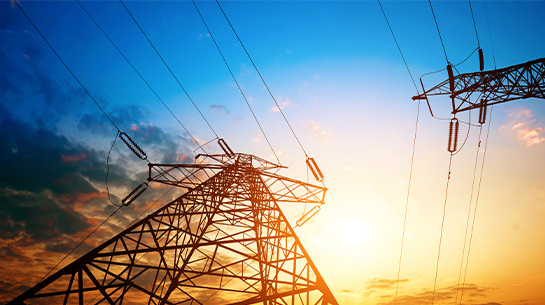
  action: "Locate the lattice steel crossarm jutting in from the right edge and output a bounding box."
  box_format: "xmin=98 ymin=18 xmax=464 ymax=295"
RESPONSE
xmin=412 ymin=58 xmax=545 ymax=114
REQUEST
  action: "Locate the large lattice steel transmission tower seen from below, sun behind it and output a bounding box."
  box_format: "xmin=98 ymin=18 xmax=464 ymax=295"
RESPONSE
xmin=8 ymin=154 xmax=338 ymax=305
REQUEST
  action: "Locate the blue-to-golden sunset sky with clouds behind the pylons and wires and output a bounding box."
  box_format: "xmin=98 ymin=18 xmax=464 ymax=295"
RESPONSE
xmin=0 ymin=0 xmax=545 ymax=305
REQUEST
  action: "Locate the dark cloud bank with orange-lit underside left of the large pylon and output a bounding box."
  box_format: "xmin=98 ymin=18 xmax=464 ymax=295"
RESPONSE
xmin=0 ymin=110 xmax=191 ymax=303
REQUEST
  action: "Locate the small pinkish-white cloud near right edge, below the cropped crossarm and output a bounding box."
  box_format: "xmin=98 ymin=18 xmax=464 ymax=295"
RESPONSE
xmin=503 ymin=108 xmax=545 ymax=147
